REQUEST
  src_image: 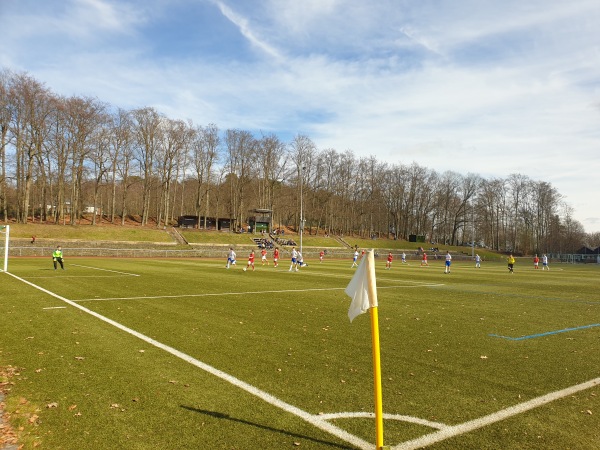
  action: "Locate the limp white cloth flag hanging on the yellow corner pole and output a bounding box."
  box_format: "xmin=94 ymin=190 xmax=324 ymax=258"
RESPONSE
xmin=344 ymin=250 xmax=377 ymax=322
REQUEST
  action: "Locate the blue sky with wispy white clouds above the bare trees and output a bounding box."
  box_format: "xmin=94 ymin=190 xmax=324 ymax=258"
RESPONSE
xmin=0 ymin=0 xmax=600 ymax=232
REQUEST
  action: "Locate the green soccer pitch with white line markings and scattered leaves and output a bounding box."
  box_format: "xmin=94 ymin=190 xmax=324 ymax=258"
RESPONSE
xmin=0 ymin=258 xmax=600 ymax=449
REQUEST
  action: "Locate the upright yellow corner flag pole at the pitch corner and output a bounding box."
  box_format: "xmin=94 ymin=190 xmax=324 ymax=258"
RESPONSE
xmin=367 ymin=250 xmax=383 ymax=450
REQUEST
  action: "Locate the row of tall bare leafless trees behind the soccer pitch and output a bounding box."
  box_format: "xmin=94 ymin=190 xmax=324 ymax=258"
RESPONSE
xmin=0 ymin=69 xmax=600 ymax=254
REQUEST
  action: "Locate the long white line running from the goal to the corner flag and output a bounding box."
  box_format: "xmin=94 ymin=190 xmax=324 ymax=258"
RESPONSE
xmin=8 ymin=273 xmax=373 ymax=450
